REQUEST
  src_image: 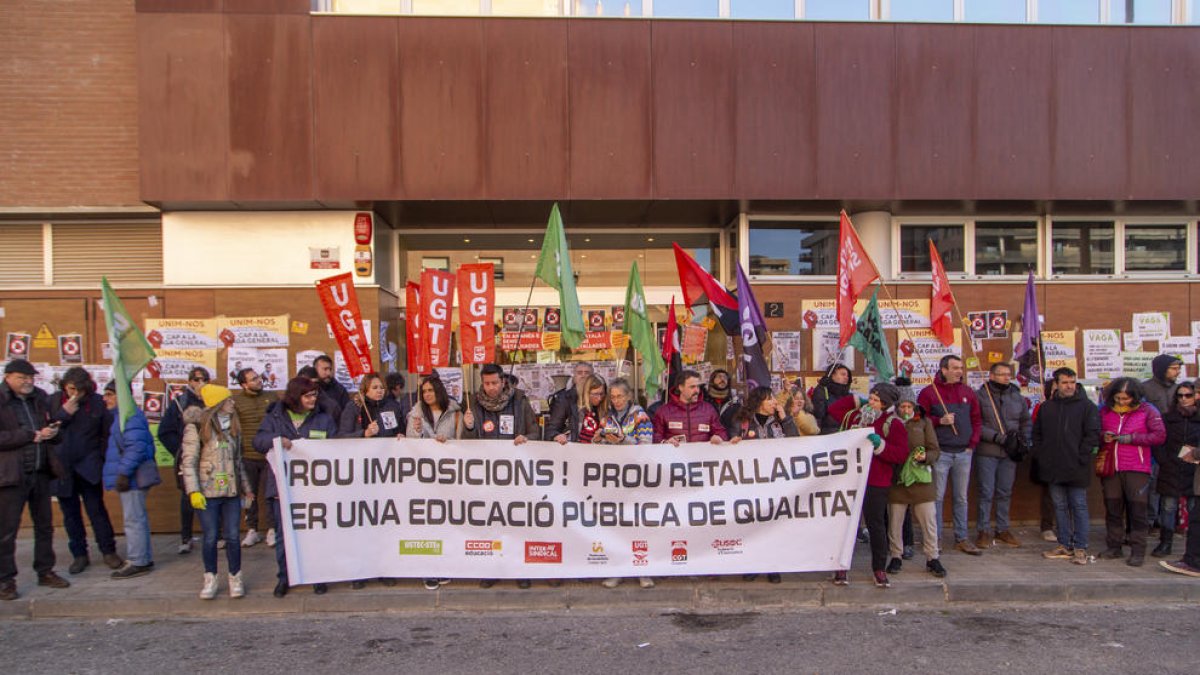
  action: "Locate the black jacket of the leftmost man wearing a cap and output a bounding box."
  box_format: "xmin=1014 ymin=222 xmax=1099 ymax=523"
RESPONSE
xmin=0 ymin=382 xmax=66 ymax=488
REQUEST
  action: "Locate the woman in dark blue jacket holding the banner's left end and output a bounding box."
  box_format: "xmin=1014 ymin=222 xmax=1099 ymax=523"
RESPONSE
xmin=254 ymin=377 xmax=337 ymax=598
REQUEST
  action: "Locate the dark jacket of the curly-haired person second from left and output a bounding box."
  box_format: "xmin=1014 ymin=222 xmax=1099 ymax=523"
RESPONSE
xmin=49 ymin=393 xmax=109 ymax=497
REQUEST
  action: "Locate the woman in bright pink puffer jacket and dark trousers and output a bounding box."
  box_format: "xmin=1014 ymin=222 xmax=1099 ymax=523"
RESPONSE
xmin=1096 ymin=377 xmax=1166 ymax=567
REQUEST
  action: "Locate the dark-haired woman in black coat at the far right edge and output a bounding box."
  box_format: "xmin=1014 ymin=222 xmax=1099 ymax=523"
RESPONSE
xmin=1150 ymin=382 xmax=1200 ymax=557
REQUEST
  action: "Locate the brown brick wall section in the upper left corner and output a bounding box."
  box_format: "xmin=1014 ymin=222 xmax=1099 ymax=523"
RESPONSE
xmin=0 ymin=0 xmax=140 ymax=208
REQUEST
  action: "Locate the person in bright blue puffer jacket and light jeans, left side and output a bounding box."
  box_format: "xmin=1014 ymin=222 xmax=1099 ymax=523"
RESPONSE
xmin=104 ymin=382 xmax=162 ymax=579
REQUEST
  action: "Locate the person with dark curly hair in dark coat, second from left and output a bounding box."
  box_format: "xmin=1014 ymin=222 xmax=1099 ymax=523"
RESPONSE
xmin=50 ymin=366 xmax=125 ymax=574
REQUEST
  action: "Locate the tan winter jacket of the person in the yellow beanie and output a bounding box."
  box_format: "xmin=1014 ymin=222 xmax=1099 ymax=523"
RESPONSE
xmin=179 ymin=401 xmax=254 ymax=500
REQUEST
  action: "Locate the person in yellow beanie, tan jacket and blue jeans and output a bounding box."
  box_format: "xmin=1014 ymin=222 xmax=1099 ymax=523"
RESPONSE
xmin=179 ymin=384 xmax=254 ymax=601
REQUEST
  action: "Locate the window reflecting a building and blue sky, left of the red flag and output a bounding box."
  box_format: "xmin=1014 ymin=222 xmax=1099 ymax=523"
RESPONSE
xmin=748 ymin=220 xmax=838 ymax=276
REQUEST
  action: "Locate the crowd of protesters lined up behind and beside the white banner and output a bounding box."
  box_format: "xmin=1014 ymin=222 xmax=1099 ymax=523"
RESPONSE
xmin=0 ymin=356 xmax=1200 ymax=599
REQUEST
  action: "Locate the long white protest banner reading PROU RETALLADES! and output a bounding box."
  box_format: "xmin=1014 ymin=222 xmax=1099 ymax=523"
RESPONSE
xmin=268 ymin=429 xmax=871 ymax=584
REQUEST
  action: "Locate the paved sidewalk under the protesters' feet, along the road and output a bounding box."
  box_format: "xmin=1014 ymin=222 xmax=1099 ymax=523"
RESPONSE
xmin=0 ymin=527 xmax=1200 ymax=620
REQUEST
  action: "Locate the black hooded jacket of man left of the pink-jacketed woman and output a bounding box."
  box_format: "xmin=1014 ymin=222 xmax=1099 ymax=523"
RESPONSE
xmin=1033 ymin=389 xmax=1100 ymax=488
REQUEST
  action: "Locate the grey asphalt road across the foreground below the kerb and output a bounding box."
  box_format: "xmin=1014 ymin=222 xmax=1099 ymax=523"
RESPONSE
xmin=0 ymin=605 xmax=1200 ymax=675
